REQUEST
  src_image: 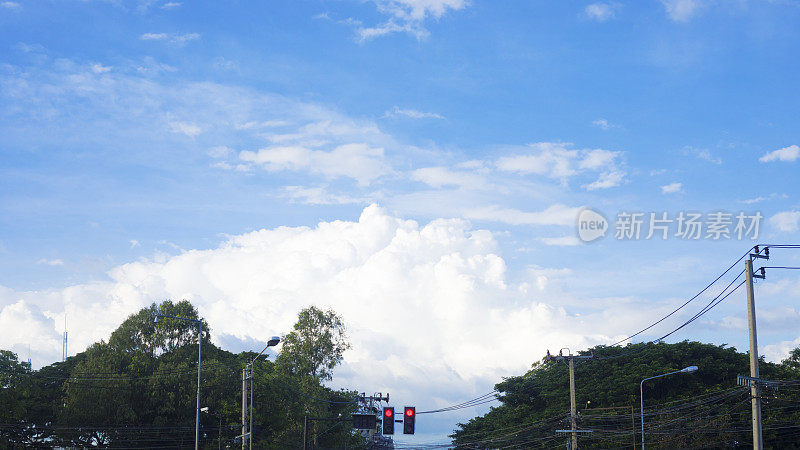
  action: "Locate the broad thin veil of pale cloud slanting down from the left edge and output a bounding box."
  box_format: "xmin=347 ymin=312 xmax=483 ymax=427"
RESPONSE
xmin=0 ymin=55 xmax=400 ymax=189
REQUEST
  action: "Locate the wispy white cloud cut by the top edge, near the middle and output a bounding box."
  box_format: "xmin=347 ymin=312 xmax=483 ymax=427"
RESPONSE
xmin=357 ymin=0 xmax=467 ymax=42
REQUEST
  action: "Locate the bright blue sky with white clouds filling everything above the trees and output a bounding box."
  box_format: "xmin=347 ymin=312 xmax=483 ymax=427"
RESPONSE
xmin=0 ymin=0 xmax=800 ymax=437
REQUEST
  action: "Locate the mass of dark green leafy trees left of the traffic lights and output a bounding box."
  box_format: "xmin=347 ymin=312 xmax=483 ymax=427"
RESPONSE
xmin=0 ymin=300 xmax=360 ymax=448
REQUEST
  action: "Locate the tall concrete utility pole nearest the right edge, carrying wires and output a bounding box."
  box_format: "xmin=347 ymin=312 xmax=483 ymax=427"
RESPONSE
xmin=744 ymin=246 xmax=769 ymax=450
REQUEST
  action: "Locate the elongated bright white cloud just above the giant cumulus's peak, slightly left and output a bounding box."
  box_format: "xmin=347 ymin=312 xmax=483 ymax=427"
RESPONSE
xmin=239 ymin=144 xmax=391 ymax=186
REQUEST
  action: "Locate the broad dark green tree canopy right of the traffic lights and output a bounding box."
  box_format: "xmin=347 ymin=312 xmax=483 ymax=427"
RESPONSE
xmin=451 ymin=341 xmax=800 ymax=448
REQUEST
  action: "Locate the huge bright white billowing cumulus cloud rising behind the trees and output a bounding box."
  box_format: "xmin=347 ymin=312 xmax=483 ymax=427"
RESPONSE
xmin=0 ymin=205 xmax=627 ymax=414
